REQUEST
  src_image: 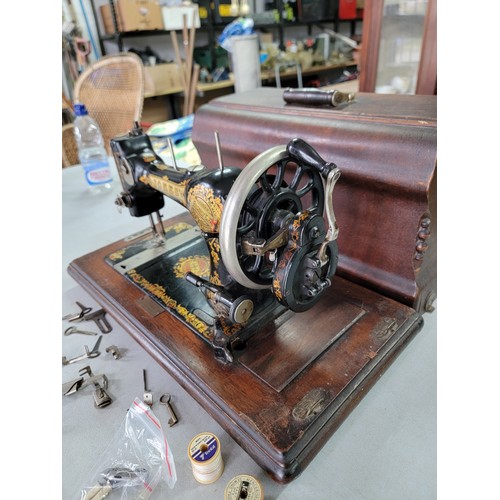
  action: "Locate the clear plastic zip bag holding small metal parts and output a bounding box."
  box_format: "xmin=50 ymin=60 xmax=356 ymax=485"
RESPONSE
xmin=80 ymin=398 xmax=177 ymax=500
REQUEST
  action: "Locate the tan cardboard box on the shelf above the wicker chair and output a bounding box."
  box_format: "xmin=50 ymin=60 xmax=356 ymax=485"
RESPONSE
xmin=99 ymin=0 xmax=163 ymax=33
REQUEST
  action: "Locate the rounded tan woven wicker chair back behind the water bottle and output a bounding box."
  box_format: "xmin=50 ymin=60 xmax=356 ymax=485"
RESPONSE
xmin=73 ymin=52 xmax=144 ymax=154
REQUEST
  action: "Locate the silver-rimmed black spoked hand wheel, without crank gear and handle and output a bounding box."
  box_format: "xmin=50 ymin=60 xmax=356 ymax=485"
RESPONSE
xmin=219 ymin=146 xmax=325 ymax=289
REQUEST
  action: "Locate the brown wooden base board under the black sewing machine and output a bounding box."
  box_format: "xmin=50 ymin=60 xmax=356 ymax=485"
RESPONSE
xmin=68 ymin=215 xmax=423 ymax=482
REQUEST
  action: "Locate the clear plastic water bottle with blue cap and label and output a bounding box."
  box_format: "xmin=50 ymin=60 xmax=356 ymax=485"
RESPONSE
xmin=74 ymin=104 xmax=113 ymax=193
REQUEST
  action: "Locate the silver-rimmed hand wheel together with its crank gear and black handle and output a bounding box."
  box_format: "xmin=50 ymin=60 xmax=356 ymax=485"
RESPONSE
xmin=220 ymin=140 xmax=338 ymax=311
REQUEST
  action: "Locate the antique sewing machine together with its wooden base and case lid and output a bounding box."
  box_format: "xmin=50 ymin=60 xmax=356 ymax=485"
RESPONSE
xmin=68 ymin=87 xmax=437 ymax=482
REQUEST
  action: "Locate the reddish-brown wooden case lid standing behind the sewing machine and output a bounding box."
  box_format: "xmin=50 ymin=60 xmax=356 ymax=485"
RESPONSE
xmin=192 ymin=87 xmax=437 ymax=312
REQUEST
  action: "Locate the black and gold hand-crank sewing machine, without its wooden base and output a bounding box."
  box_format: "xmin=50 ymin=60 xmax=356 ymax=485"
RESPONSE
xmin=111 ymin=123 xmax=340 ymax=362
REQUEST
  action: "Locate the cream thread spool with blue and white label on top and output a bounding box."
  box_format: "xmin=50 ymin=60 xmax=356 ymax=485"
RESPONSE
xmin=188 ymin=432 xmax=224 ymax=484
